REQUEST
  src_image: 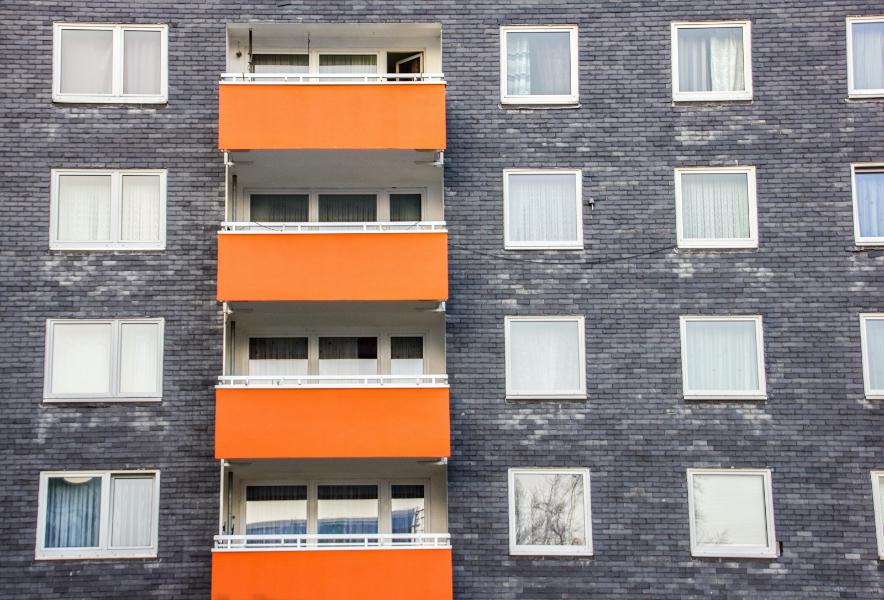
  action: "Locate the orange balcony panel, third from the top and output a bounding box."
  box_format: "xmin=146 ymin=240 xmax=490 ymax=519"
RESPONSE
xmin=215 ymin=387 xmax=451 ymax=459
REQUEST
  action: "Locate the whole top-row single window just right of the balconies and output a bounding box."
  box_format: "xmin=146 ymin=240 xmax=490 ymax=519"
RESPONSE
xmin=500 ymin=25 xmax=578 ymax=104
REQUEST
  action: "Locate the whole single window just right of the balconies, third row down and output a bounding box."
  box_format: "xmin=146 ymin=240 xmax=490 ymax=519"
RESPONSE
xmin=505 ymin=317 xmax=586 ymax=399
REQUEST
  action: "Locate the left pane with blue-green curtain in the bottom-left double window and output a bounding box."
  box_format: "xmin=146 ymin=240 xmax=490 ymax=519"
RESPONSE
xmin=43 ymin=477 xmax=101 ymax=548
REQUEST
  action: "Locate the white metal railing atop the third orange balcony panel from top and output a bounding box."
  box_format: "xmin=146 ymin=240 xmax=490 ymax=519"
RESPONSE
xmin=217 ymin=375 xmax=448 ymax=388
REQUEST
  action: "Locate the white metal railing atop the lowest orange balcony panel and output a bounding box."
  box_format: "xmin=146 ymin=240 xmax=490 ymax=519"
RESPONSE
xmin=215 ymin=533 xmax=451 ymax=551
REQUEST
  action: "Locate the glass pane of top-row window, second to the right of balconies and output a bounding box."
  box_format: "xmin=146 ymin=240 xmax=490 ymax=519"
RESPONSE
xmin=678 ymin=27 xmax=746 ymax=92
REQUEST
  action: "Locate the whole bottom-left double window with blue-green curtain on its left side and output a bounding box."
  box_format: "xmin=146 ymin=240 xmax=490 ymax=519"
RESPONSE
xmin=36 ymin=471 xmax=160 ymax=559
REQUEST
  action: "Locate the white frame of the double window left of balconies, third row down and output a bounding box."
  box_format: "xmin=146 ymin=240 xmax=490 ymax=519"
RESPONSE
xmin=43 ymin=318 xmax=165 ymax=402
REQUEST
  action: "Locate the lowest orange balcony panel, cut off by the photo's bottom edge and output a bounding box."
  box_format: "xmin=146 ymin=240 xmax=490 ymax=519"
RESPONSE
xmin=212 ymin=548 xmax=452 ymax=600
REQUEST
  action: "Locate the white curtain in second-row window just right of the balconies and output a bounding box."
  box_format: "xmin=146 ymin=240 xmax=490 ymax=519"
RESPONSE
xmin=507 ymin=174 xmax=578 ymax=242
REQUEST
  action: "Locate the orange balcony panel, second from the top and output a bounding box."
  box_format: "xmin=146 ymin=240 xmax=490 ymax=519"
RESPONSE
xmin=218 ymin=232 xmax=448 ymax=302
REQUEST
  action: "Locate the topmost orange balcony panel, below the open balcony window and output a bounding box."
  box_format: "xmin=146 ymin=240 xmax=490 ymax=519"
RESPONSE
xmin=218 ymin=83 xmax=445 ymax=150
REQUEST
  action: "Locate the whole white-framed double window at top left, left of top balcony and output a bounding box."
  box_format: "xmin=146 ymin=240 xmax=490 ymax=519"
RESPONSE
xmin=52 ymin=23 xmax=168 ymax=104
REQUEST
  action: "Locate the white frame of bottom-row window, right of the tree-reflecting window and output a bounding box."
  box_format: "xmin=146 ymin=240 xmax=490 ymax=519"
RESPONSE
xmin=687 ymin=469 xmax=779 ymax=558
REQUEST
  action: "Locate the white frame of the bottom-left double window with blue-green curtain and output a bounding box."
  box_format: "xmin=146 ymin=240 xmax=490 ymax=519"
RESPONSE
xmin=34 ymin=469 xmax=160 ymax=560
